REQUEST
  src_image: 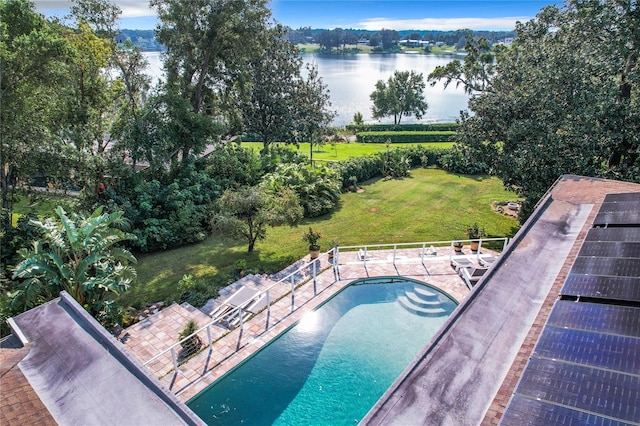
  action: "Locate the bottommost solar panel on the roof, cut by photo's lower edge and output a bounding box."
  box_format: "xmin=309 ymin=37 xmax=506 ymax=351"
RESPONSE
xmin=500 ymin=395 xmax=628 ymax=426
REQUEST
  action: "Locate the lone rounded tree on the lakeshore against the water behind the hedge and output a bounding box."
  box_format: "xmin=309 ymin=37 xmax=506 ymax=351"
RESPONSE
xmin=370 ymin=71 xmax=428 ymax=124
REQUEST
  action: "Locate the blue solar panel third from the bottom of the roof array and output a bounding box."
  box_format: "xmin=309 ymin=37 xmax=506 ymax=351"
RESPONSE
xmin=534 ymin=327 xmax=640 ymax=374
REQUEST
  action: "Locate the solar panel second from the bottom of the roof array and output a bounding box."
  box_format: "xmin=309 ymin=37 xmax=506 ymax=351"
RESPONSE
xmin=516 ymin=357 xmax=640 ymax=422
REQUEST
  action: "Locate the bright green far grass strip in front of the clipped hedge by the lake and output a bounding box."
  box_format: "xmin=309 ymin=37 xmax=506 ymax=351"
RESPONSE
xmin=242 ymin=142 xmax=453 ymax=161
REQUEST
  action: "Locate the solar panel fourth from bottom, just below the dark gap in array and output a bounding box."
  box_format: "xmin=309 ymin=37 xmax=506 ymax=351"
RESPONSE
xmin=547 ymin=300 xmax=640 ymax=338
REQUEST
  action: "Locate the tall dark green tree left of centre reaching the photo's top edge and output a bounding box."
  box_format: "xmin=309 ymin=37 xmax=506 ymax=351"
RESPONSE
xmin=151 ymin=0 xmax=270 ymax=163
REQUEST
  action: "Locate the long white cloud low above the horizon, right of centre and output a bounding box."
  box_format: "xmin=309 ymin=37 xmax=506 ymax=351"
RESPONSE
xmin=356 ymin=16 xmax=533 ymax=31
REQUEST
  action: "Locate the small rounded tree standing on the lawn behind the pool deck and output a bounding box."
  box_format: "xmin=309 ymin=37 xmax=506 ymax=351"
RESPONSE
xmin=214 ymin=186 xmax=303 ymax=253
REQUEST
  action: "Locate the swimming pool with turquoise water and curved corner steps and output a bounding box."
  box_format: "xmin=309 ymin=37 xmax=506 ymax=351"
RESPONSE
xmin=187 ymin=277 xmax=457 ymax=425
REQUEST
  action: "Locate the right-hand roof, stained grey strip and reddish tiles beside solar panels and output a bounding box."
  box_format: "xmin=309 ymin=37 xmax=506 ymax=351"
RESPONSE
xmin=362 ymin=175 xmax=640 ymax=425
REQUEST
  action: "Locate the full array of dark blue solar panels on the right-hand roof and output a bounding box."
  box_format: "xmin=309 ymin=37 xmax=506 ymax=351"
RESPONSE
xmin=501 ymin=193 xmax=640 ymax=425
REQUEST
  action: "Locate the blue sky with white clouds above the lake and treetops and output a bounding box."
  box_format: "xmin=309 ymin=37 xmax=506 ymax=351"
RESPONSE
xmin=34 ymin=0 xmax=560 ymax=31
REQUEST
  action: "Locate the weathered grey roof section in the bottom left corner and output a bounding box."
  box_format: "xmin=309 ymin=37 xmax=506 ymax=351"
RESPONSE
xmin=3 ymin=292 xmax=203 ymax=425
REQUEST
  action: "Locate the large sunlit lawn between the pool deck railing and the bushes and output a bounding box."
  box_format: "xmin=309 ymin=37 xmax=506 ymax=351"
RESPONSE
xmin=127 ymin=168 xmax=519 ymax=305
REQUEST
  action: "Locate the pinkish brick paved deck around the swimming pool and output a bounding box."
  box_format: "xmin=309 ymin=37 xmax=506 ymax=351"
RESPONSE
xmin=119 ymin=247 xmax=488 ymax=402
